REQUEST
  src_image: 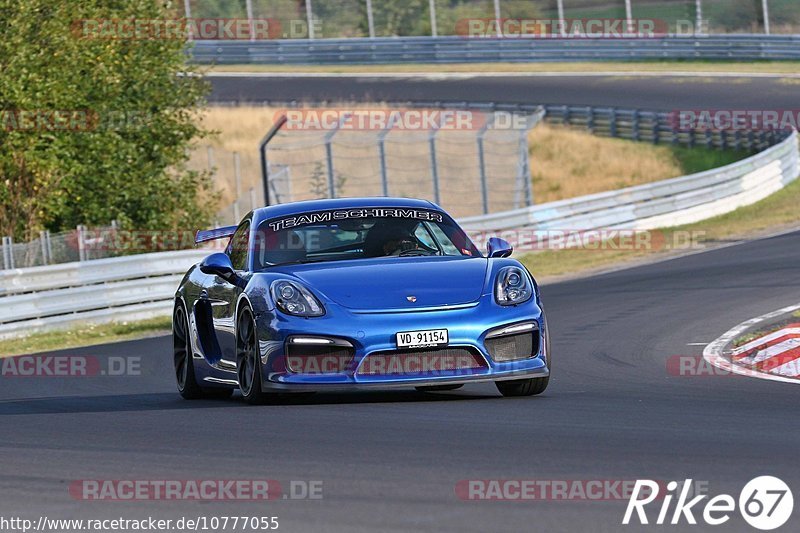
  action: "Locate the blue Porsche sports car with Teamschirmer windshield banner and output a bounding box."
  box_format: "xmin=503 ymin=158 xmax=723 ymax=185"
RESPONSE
xmin=173 ymin=198 xmax=550 ymax=403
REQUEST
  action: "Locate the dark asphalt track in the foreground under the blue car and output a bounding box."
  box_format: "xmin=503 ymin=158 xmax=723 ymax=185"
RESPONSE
xmin=0 ymin=233 xmax=800 ymax=533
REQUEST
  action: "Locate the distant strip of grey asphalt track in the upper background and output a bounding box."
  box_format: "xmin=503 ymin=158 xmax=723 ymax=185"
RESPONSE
xmin=209 ymin=75 xmax=800 ymax=111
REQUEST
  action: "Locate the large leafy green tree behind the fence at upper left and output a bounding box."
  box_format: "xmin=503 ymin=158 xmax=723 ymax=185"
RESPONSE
xmin=0 ymin=0 xmax=213 ymax=240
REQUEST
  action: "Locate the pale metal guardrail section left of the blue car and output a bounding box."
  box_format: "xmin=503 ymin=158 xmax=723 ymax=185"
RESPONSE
xmin=0 ymin=249 xmax=209 ymax=338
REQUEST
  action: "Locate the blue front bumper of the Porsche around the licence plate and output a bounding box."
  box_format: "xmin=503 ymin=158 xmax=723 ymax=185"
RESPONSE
xmin=257 ymin=295 xmax=550 ymax=391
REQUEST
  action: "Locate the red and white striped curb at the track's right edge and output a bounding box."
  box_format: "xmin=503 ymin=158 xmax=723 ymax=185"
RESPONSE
xmin=703 ymin=304 xmax=800 ymax=383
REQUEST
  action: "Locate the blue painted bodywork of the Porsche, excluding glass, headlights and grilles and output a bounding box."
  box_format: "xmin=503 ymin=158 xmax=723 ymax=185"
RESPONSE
xmin=176 ymin=198 xmax=549 ymax=391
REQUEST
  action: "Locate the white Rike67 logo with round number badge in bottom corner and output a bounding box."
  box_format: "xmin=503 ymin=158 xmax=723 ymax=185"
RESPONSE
xmin=622 ymin=476 xmax=794 ymax=531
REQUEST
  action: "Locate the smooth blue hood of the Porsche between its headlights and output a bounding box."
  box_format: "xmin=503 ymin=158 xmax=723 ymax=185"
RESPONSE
xmin=278 ymin=256 xmax=488 ymax=311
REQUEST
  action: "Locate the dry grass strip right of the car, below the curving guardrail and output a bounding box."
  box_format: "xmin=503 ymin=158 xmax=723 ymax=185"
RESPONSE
xmin=519 ymin=175 xmax=800 ymax=278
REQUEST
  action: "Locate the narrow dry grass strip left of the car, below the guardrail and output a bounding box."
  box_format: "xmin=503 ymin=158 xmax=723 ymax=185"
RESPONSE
xmin=0 ymin=317 xmax=172 ymax=358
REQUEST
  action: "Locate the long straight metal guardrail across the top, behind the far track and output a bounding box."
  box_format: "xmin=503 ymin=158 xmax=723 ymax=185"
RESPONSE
xmin=190 ymin=34 xmax=800 ymax=65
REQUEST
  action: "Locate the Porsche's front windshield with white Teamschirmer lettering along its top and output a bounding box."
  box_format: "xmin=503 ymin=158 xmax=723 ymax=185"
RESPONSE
xmin=254 ymin=208 xmax=481 ymax=269
